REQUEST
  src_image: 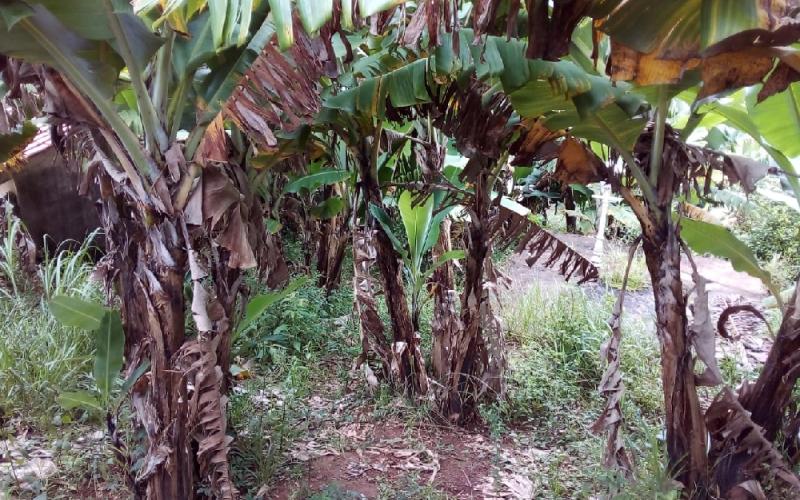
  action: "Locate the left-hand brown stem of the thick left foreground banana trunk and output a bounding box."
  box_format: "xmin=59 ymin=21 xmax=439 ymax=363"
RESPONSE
xmin=103 ymin=200 xmax=196 ymax=500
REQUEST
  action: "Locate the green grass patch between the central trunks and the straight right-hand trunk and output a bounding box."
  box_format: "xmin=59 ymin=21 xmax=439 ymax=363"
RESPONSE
xmin=496 ymin=287 xmax=676 ymax=499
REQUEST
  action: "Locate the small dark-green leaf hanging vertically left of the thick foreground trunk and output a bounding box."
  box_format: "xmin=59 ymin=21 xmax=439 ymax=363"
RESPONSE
xmin=94 ymin=311 xmax=125 ymax=398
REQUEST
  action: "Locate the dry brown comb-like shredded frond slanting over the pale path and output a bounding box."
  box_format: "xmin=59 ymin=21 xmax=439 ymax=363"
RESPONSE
xmin=494 ymin=207 xmax=600 ymax=285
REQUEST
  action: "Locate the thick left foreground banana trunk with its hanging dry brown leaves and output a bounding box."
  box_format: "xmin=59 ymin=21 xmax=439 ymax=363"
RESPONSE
xmin=98 ymin=157 xmax=253 ymax=500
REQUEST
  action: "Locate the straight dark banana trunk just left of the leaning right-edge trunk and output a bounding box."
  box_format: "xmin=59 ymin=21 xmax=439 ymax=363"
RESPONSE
xmin=642 ymin=218 xmax=707 ymax=492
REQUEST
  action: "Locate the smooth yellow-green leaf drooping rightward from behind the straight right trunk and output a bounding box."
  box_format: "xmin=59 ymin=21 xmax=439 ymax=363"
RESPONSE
xmin=681 ymin=218 xmax=780 ymax=302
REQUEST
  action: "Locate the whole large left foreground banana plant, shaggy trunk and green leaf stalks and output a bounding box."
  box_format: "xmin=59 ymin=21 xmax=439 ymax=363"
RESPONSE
xmin=0 ymin=0 xmax=406 ymax=499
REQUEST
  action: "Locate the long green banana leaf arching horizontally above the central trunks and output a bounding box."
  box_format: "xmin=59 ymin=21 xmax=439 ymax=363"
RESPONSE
xmin=321 ymin=29 xmax=645 ymax=147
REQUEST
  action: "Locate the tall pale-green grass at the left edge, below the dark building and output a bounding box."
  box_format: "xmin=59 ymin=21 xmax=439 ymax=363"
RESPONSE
xmin=0 ymin=229 xmax=102 ymax=427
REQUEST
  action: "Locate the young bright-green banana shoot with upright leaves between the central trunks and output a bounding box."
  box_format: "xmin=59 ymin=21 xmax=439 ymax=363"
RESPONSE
xmin=369 ymin=191 xmax=464 ymax=331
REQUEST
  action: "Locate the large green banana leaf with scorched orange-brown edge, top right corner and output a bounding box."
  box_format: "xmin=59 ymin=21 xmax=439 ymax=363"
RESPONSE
xmin=591 ymin=0 xmax=800 ymax=98
